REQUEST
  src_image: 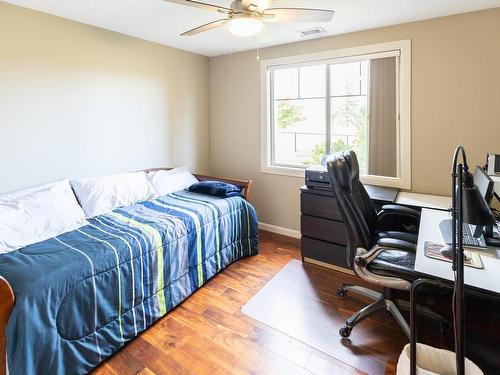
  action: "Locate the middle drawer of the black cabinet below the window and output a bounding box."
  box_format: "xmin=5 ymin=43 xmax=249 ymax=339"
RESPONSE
xmin=300 ymin=215 xmax=347 ymax=245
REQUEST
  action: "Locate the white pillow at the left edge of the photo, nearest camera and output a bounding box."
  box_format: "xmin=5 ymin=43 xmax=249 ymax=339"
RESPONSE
xmin=0 ymin=180 xmax=86 ymax=254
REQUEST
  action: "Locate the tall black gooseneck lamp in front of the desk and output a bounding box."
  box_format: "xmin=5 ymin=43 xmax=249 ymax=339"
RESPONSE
xmin=444 ymin=146 xmax=495 ymax=375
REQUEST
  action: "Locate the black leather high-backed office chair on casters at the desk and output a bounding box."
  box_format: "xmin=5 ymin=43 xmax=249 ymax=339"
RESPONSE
xmin=327 ymin=151 xmax=448 ymax=338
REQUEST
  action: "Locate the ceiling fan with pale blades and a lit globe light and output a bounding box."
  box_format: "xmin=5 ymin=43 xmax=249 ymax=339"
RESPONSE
xmin=165 ymin=0 xmax=335 ymax=36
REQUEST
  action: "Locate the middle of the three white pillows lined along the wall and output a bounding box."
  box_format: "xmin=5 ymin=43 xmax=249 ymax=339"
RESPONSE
xmin=71 ymin=172 xmax=154 ymax=217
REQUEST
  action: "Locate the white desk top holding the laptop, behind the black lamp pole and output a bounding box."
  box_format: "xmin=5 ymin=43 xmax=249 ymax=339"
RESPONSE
xmin=415 ymin=208 xmax=500 ymax=293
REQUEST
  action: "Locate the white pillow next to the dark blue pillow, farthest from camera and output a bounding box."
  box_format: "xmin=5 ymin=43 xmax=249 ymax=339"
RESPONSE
xmin=148 ymin=167 xmax=198 ymax=196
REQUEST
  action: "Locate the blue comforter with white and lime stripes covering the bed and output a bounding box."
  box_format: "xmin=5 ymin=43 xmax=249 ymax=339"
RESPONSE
xmin=0 ymin=191 xmax=258 ymax=374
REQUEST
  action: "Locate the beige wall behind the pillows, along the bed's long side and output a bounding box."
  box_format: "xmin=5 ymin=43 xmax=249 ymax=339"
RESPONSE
xmin=0 ymin=2 xmax=210 ymax=192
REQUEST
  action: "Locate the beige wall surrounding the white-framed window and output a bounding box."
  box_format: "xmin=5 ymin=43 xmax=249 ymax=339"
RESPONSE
xmin=210 ymin=8 xmax=500 ymax=229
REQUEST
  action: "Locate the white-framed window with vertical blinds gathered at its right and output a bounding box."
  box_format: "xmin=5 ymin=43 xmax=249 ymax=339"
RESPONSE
xmin=262 ymin=41 xmax=410 ymax=188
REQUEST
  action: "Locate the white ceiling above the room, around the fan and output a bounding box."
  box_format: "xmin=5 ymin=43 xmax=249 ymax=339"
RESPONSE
xmin=6 ymin=0 xmax=500 ymax=56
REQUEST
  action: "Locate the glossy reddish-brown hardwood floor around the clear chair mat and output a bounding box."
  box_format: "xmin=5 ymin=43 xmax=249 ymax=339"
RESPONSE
xmin=94 ymin=232 xmax=405 ymax=375
